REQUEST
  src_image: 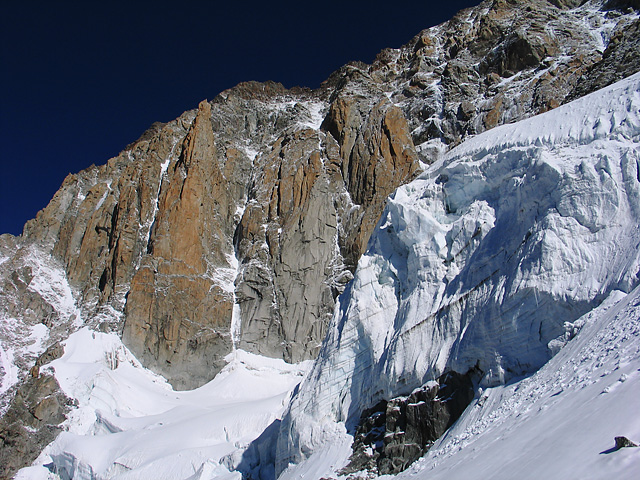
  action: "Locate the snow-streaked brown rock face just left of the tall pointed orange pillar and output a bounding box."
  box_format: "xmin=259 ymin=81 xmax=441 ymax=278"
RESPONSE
xmin=23 ymin=113 xmax=192 ymax=331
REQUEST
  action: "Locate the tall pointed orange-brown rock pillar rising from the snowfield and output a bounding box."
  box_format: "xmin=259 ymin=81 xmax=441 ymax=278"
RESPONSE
xmin=123 ymin=102 xmax=235 ymax=388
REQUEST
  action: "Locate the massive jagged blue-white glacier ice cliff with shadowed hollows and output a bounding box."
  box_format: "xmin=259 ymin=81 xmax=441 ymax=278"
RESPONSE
xmin=276 ymin=74 xmax=640 ymax=478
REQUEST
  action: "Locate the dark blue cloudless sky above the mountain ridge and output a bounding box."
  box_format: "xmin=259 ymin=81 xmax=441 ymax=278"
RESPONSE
xmin=0 ymin=0 xmax=479 ymax=235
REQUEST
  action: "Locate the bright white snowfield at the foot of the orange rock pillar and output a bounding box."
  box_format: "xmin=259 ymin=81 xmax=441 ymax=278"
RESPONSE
xmin=16 ymin=328 xmax=306 ymax=480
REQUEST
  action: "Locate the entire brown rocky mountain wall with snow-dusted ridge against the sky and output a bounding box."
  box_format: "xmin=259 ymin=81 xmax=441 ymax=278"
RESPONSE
xmin=0 ymin=0 xmax=640 ymax=475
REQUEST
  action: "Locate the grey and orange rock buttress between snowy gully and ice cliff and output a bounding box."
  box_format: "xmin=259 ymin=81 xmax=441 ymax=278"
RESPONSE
xmin=229 ymin=93 xmax=418 ymax=361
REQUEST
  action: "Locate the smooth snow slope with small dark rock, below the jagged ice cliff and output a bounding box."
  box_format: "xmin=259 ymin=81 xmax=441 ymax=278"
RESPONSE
xmin=398 ymin=288 xmax=640 ymax=480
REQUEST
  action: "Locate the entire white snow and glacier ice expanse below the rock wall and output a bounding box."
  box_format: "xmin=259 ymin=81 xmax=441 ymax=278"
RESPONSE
xmin=12 ymin=63 xmax=640 ymax=480
